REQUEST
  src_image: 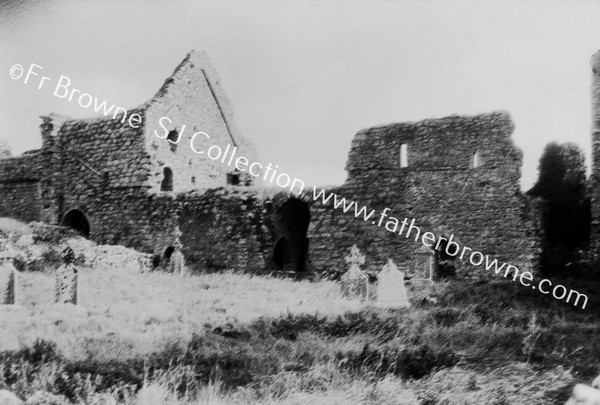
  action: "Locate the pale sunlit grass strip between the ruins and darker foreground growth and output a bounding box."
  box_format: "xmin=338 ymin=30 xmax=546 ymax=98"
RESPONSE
xmin=0 ymin=268 xmax=361 ymax=360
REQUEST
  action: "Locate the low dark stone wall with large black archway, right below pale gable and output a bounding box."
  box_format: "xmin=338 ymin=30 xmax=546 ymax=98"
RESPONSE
xmin=177 ymin=186 xmax=310 ymax=276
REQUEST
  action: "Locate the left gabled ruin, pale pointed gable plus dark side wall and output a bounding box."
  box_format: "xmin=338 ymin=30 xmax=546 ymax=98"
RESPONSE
xmin=0 ymin=52 xmax=256 ymax=257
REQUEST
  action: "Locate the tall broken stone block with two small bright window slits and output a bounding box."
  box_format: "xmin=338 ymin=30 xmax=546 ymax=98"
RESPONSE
xmin=309 ymin=113 xmax=537 ymax=278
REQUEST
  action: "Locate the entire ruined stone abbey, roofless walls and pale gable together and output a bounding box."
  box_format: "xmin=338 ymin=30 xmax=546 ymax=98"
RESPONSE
xmin=0 ymin=52 xmax=600 ymax=279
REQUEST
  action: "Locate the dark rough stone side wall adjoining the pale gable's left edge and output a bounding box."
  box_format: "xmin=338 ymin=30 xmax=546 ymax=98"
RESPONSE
xmin=43 ymin=110 xmax=169 ymax=251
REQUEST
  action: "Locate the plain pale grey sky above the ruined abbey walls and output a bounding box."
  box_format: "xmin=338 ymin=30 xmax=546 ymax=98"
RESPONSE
xmin=0 ymin=0 xmax=600 ymax=190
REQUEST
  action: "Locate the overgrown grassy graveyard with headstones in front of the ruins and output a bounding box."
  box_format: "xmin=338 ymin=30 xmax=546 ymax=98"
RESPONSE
xmin=0 ymin=219 xmax=600 ymax=405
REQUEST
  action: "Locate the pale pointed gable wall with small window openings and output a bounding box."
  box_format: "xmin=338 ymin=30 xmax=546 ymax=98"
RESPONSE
xmin=144 ymin=52 xmax=257 ymax=192
